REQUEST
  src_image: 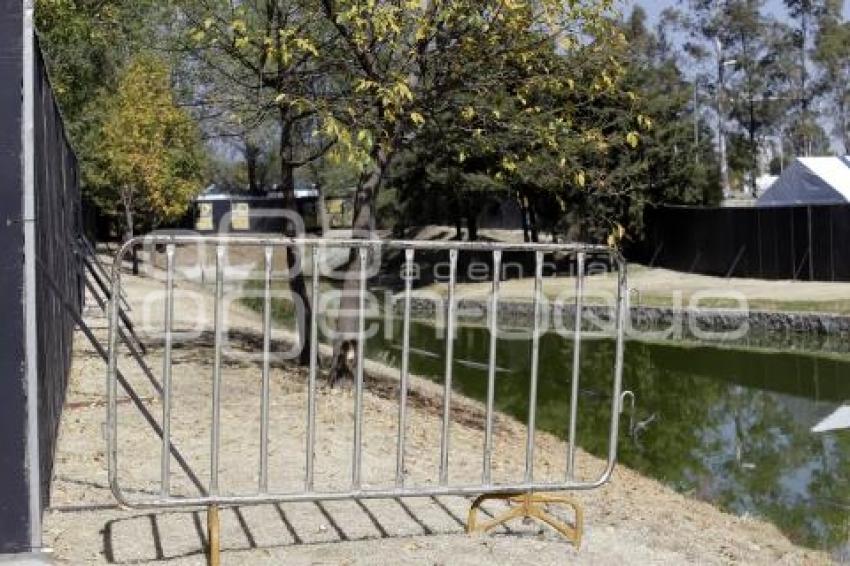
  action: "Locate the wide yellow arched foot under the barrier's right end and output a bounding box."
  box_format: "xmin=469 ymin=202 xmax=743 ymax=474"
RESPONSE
xmin=466 ymin=493 xmax=584 ymax=548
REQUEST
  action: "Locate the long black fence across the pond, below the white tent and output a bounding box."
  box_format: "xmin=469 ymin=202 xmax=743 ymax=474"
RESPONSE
xmin=627 ymin=205 xmax=850 ymax=281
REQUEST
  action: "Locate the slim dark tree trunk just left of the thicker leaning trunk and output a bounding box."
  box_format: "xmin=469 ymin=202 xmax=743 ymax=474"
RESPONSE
xmin=280 ymin=108 xmax=314 ymax=366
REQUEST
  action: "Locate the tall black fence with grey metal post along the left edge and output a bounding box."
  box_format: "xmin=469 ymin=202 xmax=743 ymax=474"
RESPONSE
xmin=0 ymin=6 xmax=83 ymax=554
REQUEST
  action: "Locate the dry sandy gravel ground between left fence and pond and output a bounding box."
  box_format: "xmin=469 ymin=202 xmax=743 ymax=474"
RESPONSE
xmin=45 ymin=264 xmax=828 ymax=564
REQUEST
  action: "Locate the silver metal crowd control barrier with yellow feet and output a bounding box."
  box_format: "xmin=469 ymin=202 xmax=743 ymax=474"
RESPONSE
xmin=107 ymin=235 xmax=628 ymax=560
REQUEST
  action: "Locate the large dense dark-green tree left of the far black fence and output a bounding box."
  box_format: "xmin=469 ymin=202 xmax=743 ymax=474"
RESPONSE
xmin=388 ymin=8 xmax=719 ymax=248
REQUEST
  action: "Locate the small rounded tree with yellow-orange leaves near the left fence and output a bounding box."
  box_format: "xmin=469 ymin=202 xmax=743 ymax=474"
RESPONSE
xmin=90 ymin=54 xmax=204 ymax=239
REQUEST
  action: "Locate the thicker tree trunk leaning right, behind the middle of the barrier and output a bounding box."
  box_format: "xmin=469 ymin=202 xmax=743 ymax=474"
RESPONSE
xmin=329 ymin=147 xmax=390 ymax=386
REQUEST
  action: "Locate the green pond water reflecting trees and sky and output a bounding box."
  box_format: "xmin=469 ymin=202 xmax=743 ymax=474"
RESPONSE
xmin=367 ymin=322 xmax=850 ymax=550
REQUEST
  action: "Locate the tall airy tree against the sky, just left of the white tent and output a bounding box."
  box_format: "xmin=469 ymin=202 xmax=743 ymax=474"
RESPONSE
xmin=675 ymin=0 xmax=801 ymax=192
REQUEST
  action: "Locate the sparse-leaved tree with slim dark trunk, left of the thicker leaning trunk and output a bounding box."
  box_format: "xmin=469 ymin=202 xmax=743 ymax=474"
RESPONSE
xmin=174 ymin=0 xmax=336 ymax=365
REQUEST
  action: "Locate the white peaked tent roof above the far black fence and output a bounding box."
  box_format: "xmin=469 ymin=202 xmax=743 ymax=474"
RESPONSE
xmin=756 ymin=157 xmax=850 ymax=206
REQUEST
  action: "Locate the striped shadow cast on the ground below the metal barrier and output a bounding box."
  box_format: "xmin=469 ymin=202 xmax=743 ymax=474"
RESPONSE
xmin=101 ymin=496 xmax=574 ymax=564
